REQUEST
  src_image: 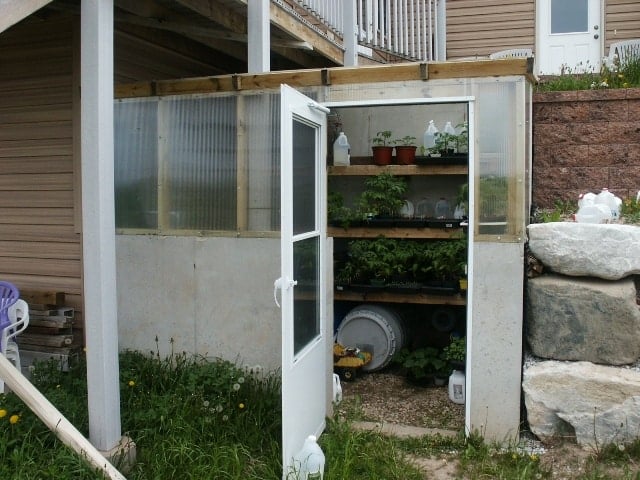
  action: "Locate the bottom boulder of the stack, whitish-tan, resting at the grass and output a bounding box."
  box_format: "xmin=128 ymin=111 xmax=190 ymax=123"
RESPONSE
xmin=522 ymin=361 xmax=640 ymax=447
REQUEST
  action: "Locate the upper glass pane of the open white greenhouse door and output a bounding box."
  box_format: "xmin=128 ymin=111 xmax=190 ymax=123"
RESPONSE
xmin=292 ymin=119 xmax=316 ymax=235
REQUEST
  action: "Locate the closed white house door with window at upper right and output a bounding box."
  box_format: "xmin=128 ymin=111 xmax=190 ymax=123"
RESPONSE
xmin=536 ymin=0 xmax=602 ymax=75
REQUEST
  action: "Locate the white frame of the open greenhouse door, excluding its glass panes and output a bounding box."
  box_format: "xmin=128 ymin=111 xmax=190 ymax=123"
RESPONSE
xmin=276 ymin=85 xmax=333 ymax=478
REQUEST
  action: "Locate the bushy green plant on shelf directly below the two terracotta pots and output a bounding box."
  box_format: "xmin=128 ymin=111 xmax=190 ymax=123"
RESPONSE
xmin=359 ymin=172 xmax=408 ymax=218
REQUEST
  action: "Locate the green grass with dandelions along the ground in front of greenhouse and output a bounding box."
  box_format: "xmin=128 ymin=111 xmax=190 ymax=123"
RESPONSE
xmin=0 ymin=352 xmax=640 ymax=480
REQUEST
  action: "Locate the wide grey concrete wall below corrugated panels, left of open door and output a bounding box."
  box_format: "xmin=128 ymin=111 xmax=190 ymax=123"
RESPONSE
xmin=116 ymin=235 xmax=281 ymax=370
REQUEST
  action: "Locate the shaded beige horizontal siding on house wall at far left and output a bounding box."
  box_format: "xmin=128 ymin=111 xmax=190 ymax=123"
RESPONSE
xmin=0 ymin=17 xmax=82 ymax=328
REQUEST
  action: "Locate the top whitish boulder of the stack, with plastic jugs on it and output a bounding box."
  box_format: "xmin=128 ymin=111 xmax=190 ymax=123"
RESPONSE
xmin=528 ymin=222 xmax=640 ymax=280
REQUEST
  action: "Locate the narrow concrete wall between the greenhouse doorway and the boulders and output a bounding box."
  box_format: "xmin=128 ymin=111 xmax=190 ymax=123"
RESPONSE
xmin=466 ymin=242 xmax=524 ymax=444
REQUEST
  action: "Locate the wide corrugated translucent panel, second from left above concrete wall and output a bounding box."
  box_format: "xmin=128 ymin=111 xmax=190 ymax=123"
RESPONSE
xmin=159 ymin=96 xmax=237 ymax=230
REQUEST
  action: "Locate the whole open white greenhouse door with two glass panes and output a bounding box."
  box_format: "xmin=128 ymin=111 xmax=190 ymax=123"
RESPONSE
xmin=276 ymin=85 xmax=330 ymax=478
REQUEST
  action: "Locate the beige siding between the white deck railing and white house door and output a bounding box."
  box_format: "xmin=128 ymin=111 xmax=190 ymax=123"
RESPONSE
xmin=447 ymin=0 xmax=535 ymax=60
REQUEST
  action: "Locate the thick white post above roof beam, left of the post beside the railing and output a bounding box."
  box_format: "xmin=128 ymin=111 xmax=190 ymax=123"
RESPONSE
xmin=247 ymin=0 xmax=271 ymax=73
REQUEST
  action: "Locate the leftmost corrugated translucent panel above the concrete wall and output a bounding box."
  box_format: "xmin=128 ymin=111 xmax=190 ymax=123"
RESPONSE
xmin=114 ymin=99 xmax=158 ymax=229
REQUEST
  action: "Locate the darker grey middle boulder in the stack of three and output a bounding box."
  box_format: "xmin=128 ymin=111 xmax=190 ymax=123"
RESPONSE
xmin=525 ymin=275 xmax=640 ymax=365
